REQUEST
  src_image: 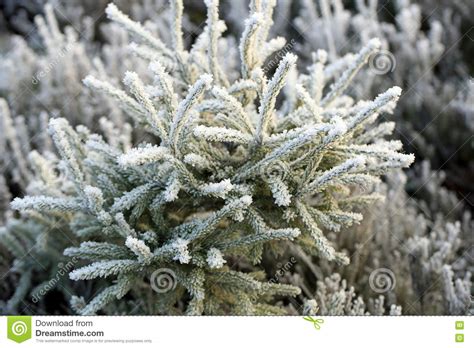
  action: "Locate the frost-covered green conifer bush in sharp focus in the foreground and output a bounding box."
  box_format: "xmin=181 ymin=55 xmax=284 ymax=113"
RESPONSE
xmin=2 ymin=1 xmax=413 ymax=315
